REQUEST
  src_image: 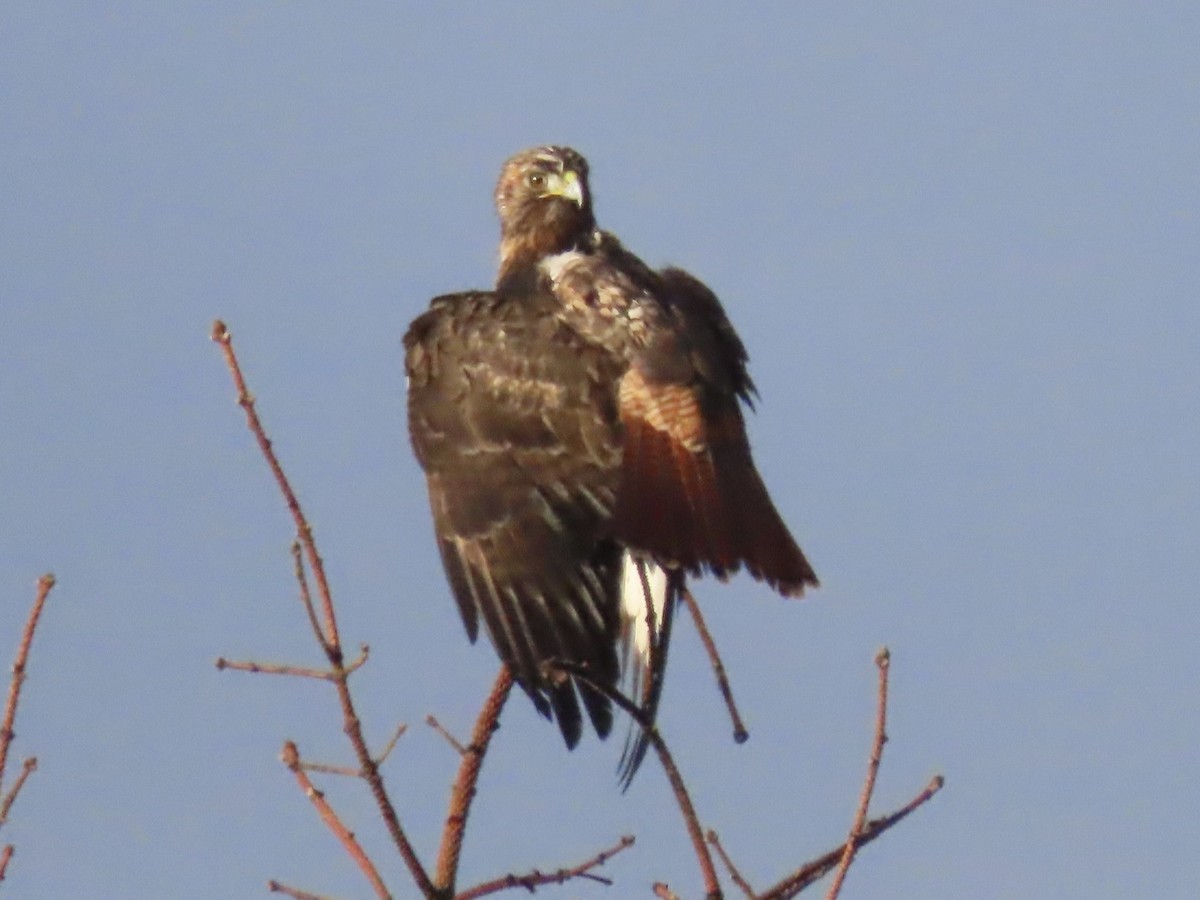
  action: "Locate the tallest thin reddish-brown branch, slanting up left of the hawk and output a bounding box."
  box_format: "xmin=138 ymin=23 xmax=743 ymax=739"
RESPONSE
xmin=212 ymin=319 xmax=437 ymax=896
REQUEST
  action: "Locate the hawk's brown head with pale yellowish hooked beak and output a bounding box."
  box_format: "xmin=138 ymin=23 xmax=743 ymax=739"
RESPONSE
xmin=496 ymin=146 xmax=595 ymax=278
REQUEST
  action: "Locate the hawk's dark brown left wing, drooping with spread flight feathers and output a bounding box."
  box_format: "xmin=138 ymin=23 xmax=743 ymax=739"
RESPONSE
xmin=404 ymin=292 xmax=622 ymax=746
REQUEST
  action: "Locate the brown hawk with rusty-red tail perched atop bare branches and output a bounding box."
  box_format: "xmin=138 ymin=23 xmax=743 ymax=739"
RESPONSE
xmin=404 ymin=146 xmax=817 ymax=786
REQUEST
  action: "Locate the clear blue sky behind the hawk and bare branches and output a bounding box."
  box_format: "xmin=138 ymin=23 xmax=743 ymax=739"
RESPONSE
xmin=0 ymin=2 xmax=1200 ymax=900
